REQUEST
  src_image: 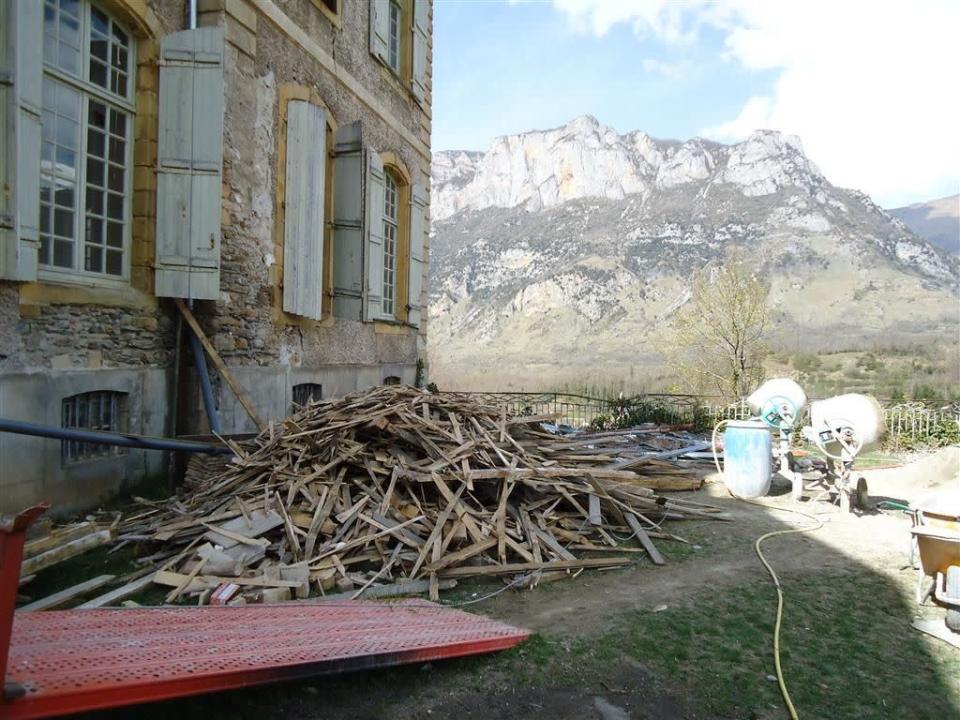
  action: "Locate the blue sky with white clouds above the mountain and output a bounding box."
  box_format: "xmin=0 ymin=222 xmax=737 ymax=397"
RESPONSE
xmin=433 ymin=0 xmax=960 ymax=207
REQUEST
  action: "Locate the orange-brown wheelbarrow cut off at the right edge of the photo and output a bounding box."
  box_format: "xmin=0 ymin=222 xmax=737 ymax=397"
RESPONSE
xmin=910 ymin=496 xmax=960 ymax=633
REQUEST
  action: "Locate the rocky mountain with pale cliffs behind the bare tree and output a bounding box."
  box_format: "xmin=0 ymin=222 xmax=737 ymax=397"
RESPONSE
xmin=430 ymin=116 xmax=960 ymax=388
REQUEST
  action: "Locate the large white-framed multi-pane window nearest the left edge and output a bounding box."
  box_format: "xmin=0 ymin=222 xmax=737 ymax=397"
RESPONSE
xmin=40 ymin=0 xmax=134 ymax=278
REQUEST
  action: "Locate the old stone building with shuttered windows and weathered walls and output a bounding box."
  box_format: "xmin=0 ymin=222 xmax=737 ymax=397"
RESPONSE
xmin=0 ymin=0 xmax=432 ymax=513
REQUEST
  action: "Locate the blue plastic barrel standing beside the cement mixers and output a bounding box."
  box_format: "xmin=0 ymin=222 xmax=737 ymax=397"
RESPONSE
xmin=723 ymin=420 xmax=773 ymax=498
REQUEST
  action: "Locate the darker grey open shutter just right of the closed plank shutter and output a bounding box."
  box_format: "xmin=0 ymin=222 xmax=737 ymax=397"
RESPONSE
xmin=333 ymin=120 xmax=364 ymax=320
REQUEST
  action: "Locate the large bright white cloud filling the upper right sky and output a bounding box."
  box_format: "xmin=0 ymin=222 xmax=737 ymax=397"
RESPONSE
xmin=553 ymin=0 xmax=960 ymax=204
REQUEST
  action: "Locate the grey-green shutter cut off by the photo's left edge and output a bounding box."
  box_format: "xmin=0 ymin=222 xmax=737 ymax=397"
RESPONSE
xmin=0 ymin=0 xmax=43 ymax=281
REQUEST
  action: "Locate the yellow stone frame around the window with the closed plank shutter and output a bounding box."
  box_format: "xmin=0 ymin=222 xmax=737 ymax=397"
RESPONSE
xmin=270 ymin=83 xmax=338 ymax=328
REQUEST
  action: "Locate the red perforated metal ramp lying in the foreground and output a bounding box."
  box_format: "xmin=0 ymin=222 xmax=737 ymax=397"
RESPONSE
xmin=0 ymin=600 xmax=529 ymax=718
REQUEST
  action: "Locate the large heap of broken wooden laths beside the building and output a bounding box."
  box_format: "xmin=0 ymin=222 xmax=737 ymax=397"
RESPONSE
xmin=119 ymin=386 xmax=717 ymax=602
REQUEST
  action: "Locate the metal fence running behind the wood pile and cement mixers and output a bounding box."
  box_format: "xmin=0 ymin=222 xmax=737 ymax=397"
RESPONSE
xmin=444 ymin=392 xmax=960 ymax=449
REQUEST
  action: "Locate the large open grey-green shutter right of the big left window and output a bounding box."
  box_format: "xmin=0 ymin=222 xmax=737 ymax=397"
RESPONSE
xmin=156 ymin=27 xmax=223 ymax=300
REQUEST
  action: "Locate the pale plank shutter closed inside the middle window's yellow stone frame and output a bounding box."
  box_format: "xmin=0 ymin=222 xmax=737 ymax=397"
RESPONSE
xmin=283 ymin=100 xmax=327 ymax=320
